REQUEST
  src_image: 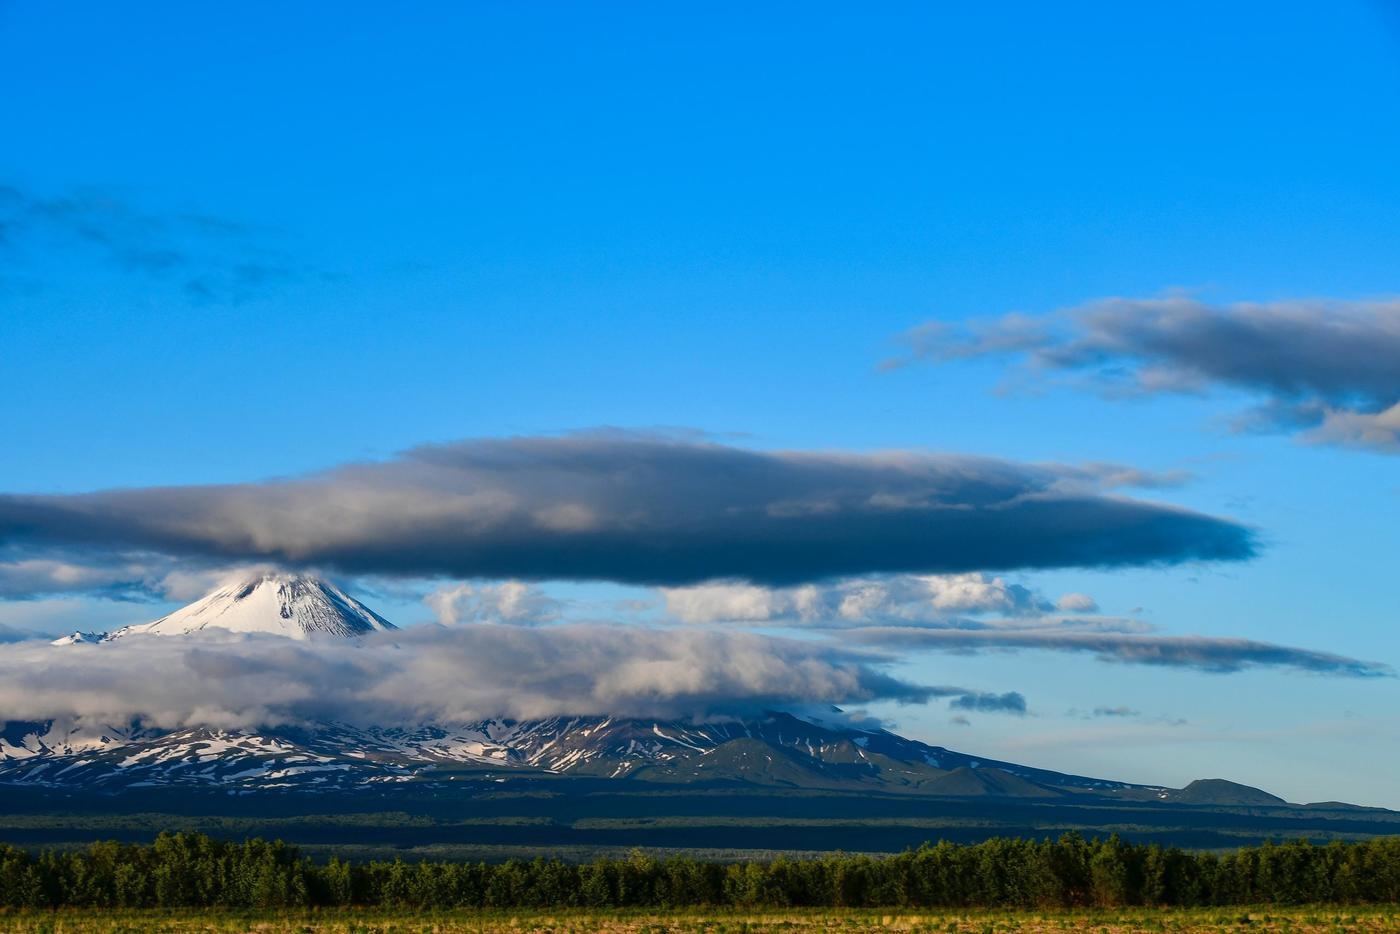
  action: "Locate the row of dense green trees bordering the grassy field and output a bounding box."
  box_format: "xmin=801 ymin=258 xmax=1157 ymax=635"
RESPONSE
xmin=0 ymin=833 xmax=1400 ymax=909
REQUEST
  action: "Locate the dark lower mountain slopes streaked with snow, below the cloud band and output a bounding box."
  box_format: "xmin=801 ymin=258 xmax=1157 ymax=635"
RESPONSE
xmin=0 ymin=713 xmax=1137 ymax=797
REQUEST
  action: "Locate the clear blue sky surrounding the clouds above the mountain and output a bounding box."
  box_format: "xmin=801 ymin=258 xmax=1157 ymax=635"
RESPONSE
xmin=0 ymin=3 xmax=1400 ymax=807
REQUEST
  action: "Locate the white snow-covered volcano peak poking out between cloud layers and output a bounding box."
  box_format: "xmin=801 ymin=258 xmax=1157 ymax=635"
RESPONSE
xmin=108 ymin=573 xmax=396 ymax=639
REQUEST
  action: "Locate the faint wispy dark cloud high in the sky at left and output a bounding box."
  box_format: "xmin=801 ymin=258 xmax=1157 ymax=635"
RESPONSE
xmin=0 ymin=185 xmax=305 ymax=301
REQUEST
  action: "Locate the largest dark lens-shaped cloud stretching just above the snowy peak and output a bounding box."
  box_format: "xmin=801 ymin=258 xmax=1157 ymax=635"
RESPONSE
xmin=0 ymin=434 xmax=1254 ymax=587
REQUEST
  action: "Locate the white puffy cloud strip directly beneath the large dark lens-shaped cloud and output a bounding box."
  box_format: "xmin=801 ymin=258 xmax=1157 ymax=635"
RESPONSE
xmin=661 ymin=573 xmax=1120 ymax=629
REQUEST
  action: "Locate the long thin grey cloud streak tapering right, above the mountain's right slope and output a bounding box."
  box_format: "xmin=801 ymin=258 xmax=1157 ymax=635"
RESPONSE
xmin=846 ymin=626 xmax=1394 ymax=678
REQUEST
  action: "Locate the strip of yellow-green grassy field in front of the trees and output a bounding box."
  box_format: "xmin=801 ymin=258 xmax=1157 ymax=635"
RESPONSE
xmin=0 ymin=906 xmax=1400 ymax=934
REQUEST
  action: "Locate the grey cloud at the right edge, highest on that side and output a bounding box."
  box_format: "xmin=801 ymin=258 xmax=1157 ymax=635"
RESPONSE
xmin=886 ymin=295 xmax=1400 ymax=452
